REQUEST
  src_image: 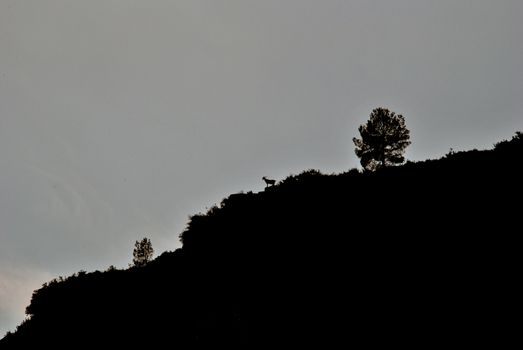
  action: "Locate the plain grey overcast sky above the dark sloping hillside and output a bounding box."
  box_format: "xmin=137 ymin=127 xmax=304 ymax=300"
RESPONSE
xmin=0 ymin=0 xmax=523 ymax=337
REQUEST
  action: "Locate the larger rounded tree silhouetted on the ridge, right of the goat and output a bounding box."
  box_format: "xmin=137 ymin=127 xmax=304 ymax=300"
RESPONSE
xmin=353 ymin=108 xmax=410 ymax=170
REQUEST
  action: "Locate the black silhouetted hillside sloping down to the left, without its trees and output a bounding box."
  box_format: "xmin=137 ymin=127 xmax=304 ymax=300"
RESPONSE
xmin=0 ymin=133 xmax=523 ymax=350
